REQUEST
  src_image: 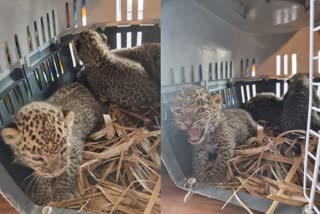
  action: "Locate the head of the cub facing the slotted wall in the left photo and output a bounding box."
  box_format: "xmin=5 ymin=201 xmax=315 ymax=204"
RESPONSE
xmin=74 ymin=30 xmax=109 ymax=64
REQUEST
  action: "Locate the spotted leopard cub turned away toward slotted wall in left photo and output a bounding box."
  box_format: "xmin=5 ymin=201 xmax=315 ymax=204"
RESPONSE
xmin=75 ymin=30 xmax=160 ymax=107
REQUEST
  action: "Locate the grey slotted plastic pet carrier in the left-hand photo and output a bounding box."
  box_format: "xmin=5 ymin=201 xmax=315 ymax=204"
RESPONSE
xmin=0 ymin=0 xmax=160 ymax=214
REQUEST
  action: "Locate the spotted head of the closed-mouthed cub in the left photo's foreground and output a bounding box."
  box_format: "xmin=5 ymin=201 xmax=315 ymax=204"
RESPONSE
xmin=1 ymin=102 xmax=74 ymax=178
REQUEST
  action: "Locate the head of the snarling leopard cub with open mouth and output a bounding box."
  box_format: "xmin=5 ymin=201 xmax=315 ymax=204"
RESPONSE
xmin=171 ymin=86 xmax=221 ymax=144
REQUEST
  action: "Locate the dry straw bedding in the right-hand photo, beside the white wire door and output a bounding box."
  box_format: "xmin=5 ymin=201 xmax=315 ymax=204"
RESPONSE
xmin=208 ymin=130 xmax=320 ymax=213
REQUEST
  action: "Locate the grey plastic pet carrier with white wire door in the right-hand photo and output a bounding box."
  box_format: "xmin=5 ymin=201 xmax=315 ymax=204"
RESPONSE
xmin=161 ymin=0 xmax=320 ymax=213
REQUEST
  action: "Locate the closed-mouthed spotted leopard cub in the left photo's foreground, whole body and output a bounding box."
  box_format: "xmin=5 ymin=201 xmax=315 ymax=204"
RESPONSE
xmin=1 ymin=83 xmax=102 ymax=205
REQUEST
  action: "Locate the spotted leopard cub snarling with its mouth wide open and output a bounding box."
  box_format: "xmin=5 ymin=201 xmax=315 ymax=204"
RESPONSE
xmin=171 ymin=86 xmax=257 ymax=183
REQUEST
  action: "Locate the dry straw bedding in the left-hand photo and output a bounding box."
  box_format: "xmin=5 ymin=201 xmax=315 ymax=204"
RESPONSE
xmin=51 ymin=105 xmax=160 ymax=214
